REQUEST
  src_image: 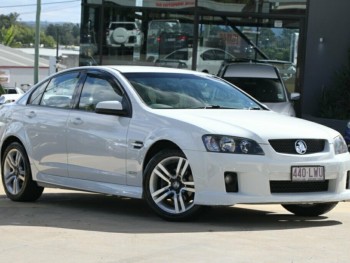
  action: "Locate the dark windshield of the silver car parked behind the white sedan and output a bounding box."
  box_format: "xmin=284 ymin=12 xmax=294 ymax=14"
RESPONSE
xmin=225 ymin=77 xmax=287 ymax=103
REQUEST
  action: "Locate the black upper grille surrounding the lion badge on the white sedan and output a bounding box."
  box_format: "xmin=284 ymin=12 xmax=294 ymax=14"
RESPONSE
xmin=269 ymin=139 xmax=326 ymax=154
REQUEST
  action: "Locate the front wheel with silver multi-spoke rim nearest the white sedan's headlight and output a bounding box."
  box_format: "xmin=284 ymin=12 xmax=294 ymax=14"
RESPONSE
xmin=144 ymin=150 xmax=201 ymax=221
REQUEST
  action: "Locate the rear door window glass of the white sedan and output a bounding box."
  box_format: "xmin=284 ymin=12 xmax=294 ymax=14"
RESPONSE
xmin=40 ymin=72 xmax=80 ymax=108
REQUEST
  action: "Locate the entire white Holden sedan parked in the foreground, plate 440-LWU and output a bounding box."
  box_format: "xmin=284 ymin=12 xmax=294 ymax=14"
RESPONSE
xmin=0 ymin=66 xmax=350 ymax=221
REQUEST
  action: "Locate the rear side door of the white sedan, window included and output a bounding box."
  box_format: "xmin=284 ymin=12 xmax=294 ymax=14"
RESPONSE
xmin=24 ymin=72 xmax=80 ymax=176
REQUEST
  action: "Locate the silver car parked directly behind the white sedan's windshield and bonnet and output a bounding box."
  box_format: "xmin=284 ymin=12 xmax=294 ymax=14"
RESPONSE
xmin=218 ymin=62 xmax=300 ymax=116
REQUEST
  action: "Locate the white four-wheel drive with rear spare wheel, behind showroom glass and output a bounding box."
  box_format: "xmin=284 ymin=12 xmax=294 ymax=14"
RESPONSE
xmin=106 ymin=22 xmax=144 ymax=48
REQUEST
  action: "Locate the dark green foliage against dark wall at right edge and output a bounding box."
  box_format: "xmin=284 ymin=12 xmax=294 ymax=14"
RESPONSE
xmin=319 ymin=49 xmax=350 ymax=120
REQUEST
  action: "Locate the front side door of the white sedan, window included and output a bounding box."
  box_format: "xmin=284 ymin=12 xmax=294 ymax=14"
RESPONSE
xmin=67 ymin=72 xmax=130 ymax=184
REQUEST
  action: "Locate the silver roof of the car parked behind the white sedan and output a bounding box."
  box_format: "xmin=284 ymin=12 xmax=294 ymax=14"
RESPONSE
xmin=222 ymin=63 xmax=278 ymax=79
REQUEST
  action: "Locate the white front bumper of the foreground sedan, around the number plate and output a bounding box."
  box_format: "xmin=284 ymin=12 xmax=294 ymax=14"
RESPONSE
xmin=185 ymin=149 xmax=350 ymax=205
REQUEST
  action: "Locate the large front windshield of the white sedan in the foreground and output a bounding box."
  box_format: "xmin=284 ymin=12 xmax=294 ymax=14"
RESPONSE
xmin=124 ymin=73 xmax=262 ymax=110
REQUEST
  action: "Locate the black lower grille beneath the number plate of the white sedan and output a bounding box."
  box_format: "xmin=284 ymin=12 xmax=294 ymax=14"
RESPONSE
xmin=270 ymin=180 xmax=329 ymax=193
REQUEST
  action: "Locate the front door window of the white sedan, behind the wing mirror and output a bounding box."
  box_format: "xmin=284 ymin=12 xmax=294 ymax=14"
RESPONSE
xmin=78 ymin=76 xmax=122 ymax=111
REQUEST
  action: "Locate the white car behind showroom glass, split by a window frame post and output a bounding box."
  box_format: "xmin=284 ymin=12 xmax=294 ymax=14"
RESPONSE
xmin=155 ymin=47 xmax=234 ymax=75
